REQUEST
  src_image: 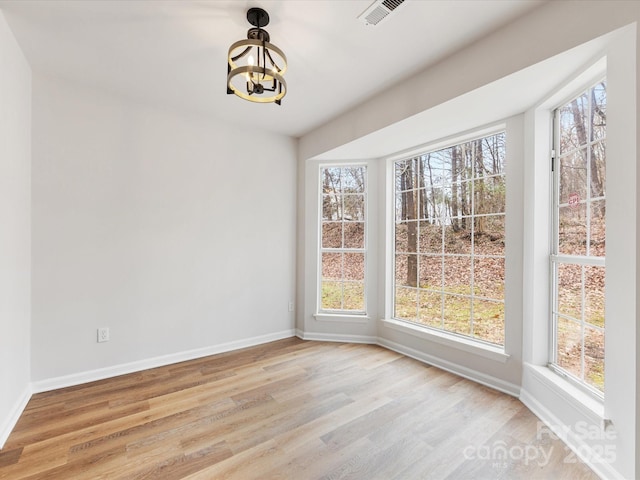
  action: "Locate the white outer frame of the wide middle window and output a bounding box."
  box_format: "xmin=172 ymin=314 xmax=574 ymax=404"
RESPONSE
xmin=384 ymin=125 xmax=509 ymax=346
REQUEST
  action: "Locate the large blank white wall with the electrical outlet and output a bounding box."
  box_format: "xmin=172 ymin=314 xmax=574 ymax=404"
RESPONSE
xmin=32 ymin=76 xmax=296 ymax=390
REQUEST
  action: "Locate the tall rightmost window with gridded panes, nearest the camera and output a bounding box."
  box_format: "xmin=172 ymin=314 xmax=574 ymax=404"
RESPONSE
xmin=551 ymin=80 xmax=606 ymax=394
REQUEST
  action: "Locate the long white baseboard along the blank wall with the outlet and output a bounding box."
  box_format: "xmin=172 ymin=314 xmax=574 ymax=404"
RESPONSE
xmin=31 ymin=329 xmax=296 ymax=393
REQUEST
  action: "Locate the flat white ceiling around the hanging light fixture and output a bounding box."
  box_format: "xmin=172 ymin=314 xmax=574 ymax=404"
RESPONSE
xmin=0 ymin=0 xmax=544 ymax=137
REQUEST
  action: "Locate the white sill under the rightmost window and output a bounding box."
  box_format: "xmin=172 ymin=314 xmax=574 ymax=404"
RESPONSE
xmin=525 ymin=364 xmax=605 ymax=425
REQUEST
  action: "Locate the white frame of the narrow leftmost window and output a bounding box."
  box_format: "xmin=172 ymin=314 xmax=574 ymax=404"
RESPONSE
xmin=314 ymin=161 xmax=370 ymax=316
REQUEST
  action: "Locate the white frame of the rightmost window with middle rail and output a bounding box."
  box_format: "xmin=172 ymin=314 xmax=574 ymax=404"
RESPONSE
xmin=547 ymin=77 xmax=609 ymax=402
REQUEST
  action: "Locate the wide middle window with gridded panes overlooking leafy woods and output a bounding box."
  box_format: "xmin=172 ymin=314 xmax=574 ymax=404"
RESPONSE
xmin=393 ymin=132 xmax=506 ymax=345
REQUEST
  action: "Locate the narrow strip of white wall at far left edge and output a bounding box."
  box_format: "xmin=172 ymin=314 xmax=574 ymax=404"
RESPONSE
xmin=0 ymin=13 xmax=31 ymax=448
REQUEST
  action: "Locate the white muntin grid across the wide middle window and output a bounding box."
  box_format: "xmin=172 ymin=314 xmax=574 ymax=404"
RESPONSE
xmin=392 ymin=131 xmax=506 ymax=346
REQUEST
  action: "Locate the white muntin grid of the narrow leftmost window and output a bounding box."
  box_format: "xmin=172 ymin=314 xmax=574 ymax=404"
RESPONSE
xmin=317 ymin=164 xmax=368 ymax=315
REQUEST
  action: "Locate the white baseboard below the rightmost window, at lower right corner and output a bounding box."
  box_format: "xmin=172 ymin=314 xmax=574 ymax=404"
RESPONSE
xmin=520 ymin=388 xmax=625 ymax=480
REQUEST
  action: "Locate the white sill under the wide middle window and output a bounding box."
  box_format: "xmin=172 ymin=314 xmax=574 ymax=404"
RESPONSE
xmin=382 ymin=319 xmax=510 ymax=363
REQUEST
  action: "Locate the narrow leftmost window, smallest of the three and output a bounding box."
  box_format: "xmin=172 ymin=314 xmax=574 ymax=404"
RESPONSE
xmin=319 ymin=165 xmax=367 ymax=314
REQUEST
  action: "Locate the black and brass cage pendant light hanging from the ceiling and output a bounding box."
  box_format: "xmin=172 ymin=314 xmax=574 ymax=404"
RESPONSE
xmin=227 ymin=8 xmax=287 ymax=105
